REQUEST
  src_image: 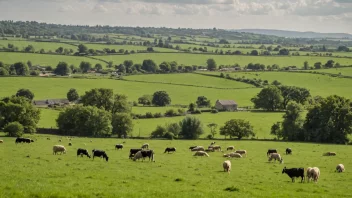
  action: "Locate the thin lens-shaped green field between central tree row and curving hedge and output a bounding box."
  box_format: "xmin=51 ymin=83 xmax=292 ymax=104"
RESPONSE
xmin=124 ymin=73 xmax=254 ymax=89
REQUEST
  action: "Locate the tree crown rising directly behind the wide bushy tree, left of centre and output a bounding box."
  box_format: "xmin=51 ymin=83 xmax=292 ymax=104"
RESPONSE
xmin=80 ymin=88 xmax=114 ymax=111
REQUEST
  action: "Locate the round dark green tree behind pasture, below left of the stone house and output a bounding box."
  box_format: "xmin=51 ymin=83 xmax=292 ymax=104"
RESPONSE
xmin=179 ymin=116 xmax=204 ymax=139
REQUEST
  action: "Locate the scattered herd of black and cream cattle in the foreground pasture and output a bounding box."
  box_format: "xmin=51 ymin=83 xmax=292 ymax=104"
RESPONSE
xmin=0 ymin=137 xmax=345 ymax=182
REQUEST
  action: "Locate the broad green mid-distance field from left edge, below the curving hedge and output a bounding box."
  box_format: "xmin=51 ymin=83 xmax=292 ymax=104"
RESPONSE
xmin=0 ymin=77 xmax=260 ymax=106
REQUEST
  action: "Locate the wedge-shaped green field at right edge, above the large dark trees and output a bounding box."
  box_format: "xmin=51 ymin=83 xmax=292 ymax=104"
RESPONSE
xmin=204 ymin=70 xmax=352 ymax=98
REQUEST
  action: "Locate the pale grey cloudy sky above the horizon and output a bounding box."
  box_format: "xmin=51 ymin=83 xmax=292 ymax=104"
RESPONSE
xmin=0 ymin=0 xmax=352 ymax=33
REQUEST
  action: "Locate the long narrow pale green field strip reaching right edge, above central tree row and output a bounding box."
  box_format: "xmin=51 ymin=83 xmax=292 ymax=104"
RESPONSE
xmin=99 ymin=53 xmax=352 ymax=67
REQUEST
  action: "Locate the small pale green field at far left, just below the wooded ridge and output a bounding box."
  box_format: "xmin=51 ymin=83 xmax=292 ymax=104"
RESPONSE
xmin=0 ymin=40 xmax=77 ymax=52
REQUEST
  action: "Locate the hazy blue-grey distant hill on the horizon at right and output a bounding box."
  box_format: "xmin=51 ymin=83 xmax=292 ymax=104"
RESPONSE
xmin=232 ymin=29 xmax=352 ymax=39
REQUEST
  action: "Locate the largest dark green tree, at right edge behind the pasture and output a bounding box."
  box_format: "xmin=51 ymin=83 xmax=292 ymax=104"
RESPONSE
xmin=303 ymin=95 xmax=352 ymax=144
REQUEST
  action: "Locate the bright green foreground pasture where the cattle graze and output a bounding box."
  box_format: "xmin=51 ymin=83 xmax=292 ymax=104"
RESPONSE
xmin=0 ymin=135 xmax=352 ymax=198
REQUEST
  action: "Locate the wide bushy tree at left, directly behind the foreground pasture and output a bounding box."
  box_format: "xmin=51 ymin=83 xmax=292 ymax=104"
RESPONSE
xmin=56 ymin=106 xmax=112 ymax=137
